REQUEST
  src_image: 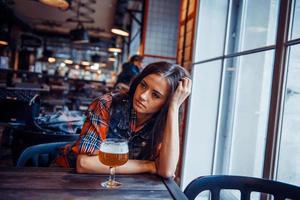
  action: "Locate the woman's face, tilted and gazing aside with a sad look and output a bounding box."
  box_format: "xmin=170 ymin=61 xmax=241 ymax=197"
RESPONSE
xmin=133 ymin=74 xmax=170 ymax=115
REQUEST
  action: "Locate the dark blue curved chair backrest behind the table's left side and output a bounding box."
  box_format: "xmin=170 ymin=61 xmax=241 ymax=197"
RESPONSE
xmin=16 ymin=142 xmax=70 ymax=168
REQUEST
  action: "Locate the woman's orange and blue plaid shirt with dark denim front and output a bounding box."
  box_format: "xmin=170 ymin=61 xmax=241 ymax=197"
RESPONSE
xmin=56 ymin=93 xmax=153 ymax=167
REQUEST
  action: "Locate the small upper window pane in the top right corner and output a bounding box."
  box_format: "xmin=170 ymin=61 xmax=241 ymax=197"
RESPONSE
xmin=290 ymin=0 xmax=300 ymax=39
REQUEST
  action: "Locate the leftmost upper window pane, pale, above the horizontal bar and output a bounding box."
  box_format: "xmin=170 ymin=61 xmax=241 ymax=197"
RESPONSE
xmin=195 ymin=0 xmax=228 ymax=62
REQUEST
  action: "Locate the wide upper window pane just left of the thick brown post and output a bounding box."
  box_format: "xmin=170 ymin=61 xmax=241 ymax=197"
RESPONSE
xmin=227 ymin=0 xmax=279 ymax=53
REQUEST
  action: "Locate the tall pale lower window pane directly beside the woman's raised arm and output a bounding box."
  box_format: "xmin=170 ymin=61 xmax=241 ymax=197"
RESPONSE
xmin=181 ymin=61 xmax=222 ymax=188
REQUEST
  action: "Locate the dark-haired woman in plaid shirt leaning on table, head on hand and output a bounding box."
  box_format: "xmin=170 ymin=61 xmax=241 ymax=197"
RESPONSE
xmin=58 ymin=62 xmax=192 ymax=177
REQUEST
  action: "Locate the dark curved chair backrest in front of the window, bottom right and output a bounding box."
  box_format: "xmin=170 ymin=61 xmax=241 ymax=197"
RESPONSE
xmin=184 ymin=175 xmax=300 ymax=200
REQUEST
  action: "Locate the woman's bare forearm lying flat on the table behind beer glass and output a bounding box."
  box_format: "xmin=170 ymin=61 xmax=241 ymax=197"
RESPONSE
xmin=76 ymin=154 xmax=156 ymax=174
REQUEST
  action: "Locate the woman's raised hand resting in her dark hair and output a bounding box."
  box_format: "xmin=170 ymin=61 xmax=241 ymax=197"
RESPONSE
xmin=170 ymin=77 xmax=192 ymax=109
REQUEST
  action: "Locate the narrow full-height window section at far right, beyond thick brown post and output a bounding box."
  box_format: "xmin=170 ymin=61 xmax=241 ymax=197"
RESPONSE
xmin=276 ymin=0 xmax=300 ymax=185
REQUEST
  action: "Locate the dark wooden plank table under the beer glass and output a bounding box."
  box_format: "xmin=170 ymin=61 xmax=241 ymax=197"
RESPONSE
xmin=0 ymin=168 xmax=187 ymax=200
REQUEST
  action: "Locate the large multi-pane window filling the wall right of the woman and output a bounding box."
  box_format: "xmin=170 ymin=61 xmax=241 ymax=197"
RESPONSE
xmin=181 ymin=0 xmax=300 ymax=192
